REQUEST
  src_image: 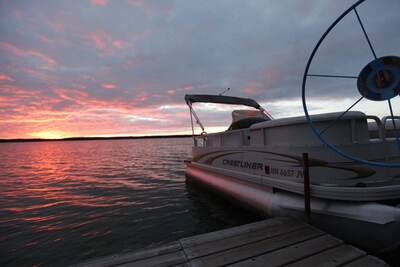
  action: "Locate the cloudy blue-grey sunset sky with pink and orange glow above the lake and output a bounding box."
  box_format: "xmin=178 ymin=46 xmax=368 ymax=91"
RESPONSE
xmin=0 ymin=0 xmax=400 ymax=139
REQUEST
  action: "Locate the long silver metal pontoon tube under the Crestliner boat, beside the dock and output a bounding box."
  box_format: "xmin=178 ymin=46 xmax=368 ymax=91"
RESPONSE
xmin=186 ymin=162 xmax=400 ymax=252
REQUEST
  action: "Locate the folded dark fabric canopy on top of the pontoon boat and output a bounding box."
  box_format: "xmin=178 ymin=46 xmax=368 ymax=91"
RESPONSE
xmin=185 ymin=95 xmax=261 ymax=109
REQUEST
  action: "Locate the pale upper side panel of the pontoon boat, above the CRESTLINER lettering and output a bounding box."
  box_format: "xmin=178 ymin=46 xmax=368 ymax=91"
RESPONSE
xmin=194 ymin=115 xmax=400 ymax=150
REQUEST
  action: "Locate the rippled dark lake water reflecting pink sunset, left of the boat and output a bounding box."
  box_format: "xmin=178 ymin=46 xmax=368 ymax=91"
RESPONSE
xmin=0 ymin=138 xmax=259 ymax=266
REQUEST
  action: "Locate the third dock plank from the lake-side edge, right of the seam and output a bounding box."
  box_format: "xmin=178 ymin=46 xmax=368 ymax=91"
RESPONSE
xmin=231 ymin=235 xmax=343 ymax=267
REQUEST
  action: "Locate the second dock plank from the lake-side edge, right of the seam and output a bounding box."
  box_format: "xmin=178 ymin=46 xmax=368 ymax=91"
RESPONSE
xmin=190 ymin=227 xmax=323 ymax=267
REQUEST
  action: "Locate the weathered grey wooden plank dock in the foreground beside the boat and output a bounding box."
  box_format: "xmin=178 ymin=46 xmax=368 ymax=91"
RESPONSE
xmin=73 ymin=218 xmax=389 ymax=267
